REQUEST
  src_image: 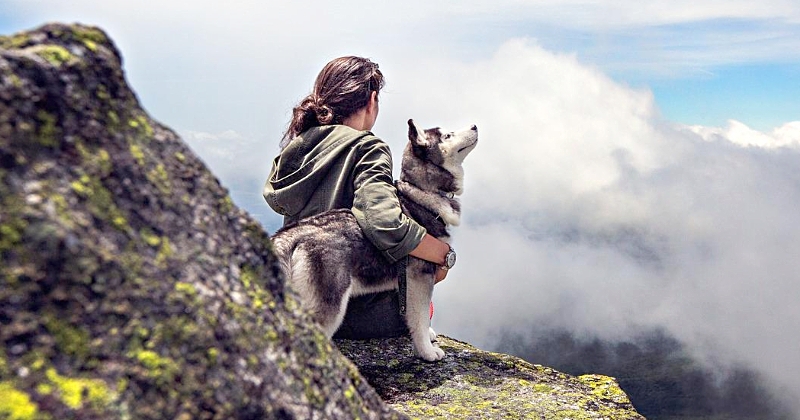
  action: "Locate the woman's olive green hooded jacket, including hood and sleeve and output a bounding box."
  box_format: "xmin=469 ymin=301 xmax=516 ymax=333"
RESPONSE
xmin=264 ymin=125 xmax=426 ymax=263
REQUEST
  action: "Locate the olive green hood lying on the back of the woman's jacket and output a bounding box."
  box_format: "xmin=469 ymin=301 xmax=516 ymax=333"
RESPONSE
xmin=264 ymin=125 xmax=372 ymax=216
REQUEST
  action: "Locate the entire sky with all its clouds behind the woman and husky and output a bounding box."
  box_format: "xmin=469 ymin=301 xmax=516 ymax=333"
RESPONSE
xmin=0 ymin=0 xmax=800 ymax=414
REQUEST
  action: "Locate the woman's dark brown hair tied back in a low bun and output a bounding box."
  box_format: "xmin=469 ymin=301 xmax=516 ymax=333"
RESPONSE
xmin=281 ymin=56 xmax=384 ymax=148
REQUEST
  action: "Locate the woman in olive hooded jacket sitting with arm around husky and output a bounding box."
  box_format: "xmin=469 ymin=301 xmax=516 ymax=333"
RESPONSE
xmin=264 ymin=56 xmax=450 ymax=338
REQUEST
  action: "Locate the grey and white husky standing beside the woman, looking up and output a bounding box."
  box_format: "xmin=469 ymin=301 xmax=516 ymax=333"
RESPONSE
xmin=272 ymin=120 xmax=478 ymax=361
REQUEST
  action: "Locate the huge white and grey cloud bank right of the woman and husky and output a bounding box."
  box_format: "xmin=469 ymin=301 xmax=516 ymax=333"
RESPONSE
xmin=390 ymin=40 xmax=800 ymax=414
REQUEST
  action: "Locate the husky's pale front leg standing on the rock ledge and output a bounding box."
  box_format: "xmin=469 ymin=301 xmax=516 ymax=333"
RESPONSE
xmin=406 ymin=258 xmax=444 ymax=362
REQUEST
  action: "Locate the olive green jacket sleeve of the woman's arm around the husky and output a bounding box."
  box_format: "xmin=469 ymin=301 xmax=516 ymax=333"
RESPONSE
xmin=352 ymin=136 xmax=426 ymax=263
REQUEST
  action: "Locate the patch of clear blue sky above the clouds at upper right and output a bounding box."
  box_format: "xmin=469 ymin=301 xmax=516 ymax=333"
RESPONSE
xmin=518 ymin=14 xmax=800 ymax=131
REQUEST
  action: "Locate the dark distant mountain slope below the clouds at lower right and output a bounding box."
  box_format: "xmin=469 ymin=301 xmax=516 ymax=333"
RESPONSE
xmin=498 ymin=329 xmax=797 ymax=420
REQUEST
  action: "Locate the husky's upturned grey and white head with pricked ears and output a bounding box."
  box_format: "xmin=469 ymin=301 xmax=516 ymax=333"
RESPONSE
xmin=402 ymin=120 xmax=478 ymax=194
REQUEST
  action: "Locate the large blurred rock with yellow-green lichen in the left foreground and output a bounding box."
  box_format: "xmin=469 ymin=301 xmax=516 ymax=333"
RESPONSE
xmin=0 ymin=24 xmax=403 ymax=419
